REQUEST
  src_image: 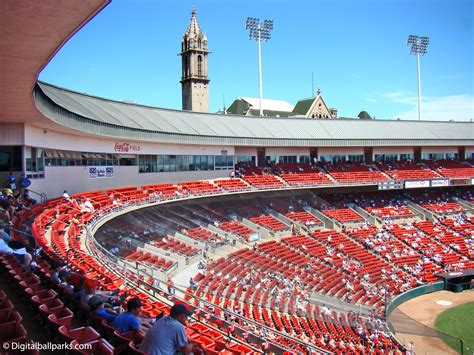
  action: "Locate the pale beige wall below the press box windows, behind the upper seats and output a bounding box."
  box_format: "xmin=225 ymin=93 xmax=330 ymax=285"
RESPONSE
xmin=30 ymin=166 xmax=230 ymax=199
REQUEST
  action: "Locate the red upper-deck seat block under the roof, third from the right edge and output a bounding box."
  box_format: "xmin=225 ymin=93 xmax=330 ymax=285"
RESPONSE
xmin=326 ymin=164 xmax=390 ymax=183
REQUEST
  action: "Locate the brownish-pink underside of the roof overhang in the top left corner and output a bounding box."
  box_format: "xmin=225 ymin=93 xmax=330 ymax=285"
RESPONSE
xmin=0 ymin=0 xmax=110 ymax=127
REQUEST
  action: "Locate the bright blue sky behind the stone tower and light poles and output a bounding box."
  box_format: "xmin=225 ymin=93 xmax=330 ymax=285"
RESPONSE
xmin=40 ymin=0 xmax=474 ymax=120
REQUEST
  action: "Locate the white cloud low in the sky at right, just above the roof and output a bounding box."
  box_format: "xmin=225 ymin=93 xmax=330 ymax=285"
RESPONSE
xmin=384 ymin=92 xmax=474 ymax=121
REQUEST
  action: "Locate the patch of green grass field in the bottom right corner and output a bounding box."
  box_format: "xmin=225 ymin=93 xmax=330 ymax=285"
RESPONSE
xmin=435 ymin=302 xmax=474 ymax=354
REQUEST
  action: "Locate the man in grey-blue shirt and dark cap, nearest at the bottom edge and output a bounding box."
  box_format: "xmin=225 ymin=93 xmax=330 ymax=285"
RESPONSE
xmin=140 ymin=303 xmax=196 ymax=355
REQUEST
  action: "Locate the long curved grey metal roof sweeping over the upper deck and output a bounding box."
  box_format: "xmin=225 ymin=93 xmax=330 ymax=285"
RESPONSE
xmin=35 ymin=83 xmax=474 ymax=147
